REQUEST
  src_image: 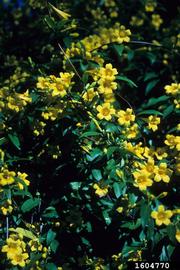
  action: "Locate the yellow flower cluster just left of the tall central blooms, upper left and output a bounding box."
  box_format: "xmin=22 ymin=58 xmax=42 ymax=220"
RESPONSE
xmin=36 ymin=72 xmax=74 ymax=98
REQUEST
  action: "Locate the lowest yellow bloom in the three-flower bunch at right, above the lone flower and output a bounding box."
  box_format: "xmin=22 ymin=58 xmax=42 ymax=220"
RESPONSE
xmin=133 ymin=170 xmax=153 ymax=190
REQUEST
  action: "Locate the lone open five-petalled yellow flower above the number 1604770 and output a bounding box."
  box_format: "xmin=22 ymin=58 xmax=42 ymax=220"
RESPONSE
xmin=151 ymin=205 xmax=173 ymax=226
